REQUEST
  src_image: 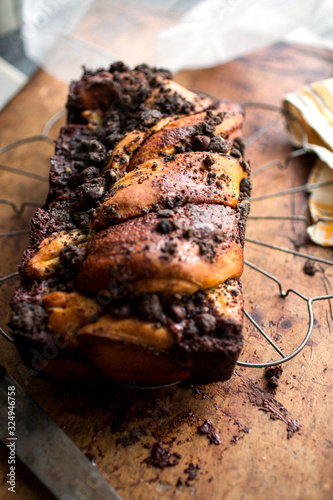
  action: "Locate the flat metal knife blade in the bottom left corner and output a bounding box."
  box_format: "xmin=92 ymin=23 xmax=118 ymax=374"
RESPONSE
xmin=0 ymin=367 xmax=122 ymax=500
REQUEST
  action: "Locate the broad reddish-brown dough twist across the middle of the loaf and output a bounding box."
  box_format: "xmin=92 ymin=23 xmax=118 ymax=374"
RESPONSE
xmin=76 ymin=204 xmax=243 ymax=297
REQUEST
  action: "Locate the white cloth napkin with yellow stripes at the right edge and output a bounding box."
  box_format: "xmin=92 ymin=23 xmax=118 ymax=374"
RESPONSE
xmin=283 ymin=78 xmax=333 ymax=246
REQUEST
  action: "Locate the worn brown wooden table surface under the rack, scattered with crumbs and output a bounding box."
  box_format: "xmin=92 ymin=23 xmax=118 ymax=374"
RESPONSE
xmin=0 ymin=44 xmax=333 ymax=500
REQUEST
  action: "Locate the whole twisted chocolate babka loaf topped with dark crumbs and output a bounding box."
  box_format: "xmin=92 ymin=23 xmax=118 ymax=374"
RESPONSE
xmin=9 ymin=63 xmax=251 ymax=384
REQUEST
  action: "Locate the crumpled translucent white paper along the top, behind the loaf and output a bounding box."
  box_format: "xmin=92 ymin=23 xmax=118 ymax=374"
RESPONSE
xmin=22 ymin=0 xmax=333 ymax=82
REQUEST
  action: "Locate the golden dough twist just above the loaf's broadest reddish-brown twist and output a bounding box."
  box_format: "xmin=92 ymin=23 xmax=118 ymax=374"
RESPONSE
xmin=92 ymin=152 xmax=248 ymax=229
